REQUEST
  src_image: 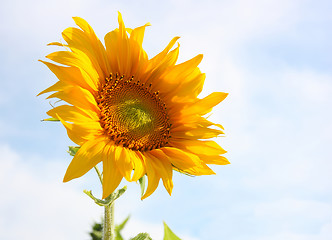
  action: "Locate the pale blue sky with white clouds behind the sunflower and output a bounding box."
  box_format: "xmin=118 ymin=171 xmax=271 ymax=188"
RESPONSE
xmin=0 ymin=0 xmax=332 ymax=240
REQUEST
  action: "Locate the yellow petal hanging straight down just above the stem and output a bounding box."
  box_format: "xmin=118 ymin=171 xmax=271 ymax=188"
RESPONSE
xmin=103 ymin=143 xmax=123 ymax=198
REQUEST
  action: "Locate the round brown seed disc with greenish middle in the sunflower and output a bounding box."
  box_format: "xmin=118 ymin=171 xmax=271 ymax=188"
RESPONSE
xmin=97 ymin=74 xmax=171 ymax=151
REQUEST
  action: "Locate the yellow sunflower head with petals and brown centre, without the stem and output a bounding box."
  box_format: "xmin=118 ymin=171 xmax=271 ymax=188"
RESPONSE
xmin=40 ymin=13 xmax=229 ymax=199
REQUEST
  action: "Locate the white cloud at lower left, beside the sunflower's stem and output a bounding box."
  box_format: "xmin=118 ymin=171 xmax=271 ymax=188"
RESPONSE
xmin=0 ymin=145 xmax=100 ymax=240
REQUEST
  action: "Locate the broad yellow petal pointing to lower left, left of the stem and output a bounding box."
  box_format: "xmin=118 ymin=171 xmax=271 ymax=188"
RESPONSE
xmin=63 ymin=138 xmax=109 ymax=182
